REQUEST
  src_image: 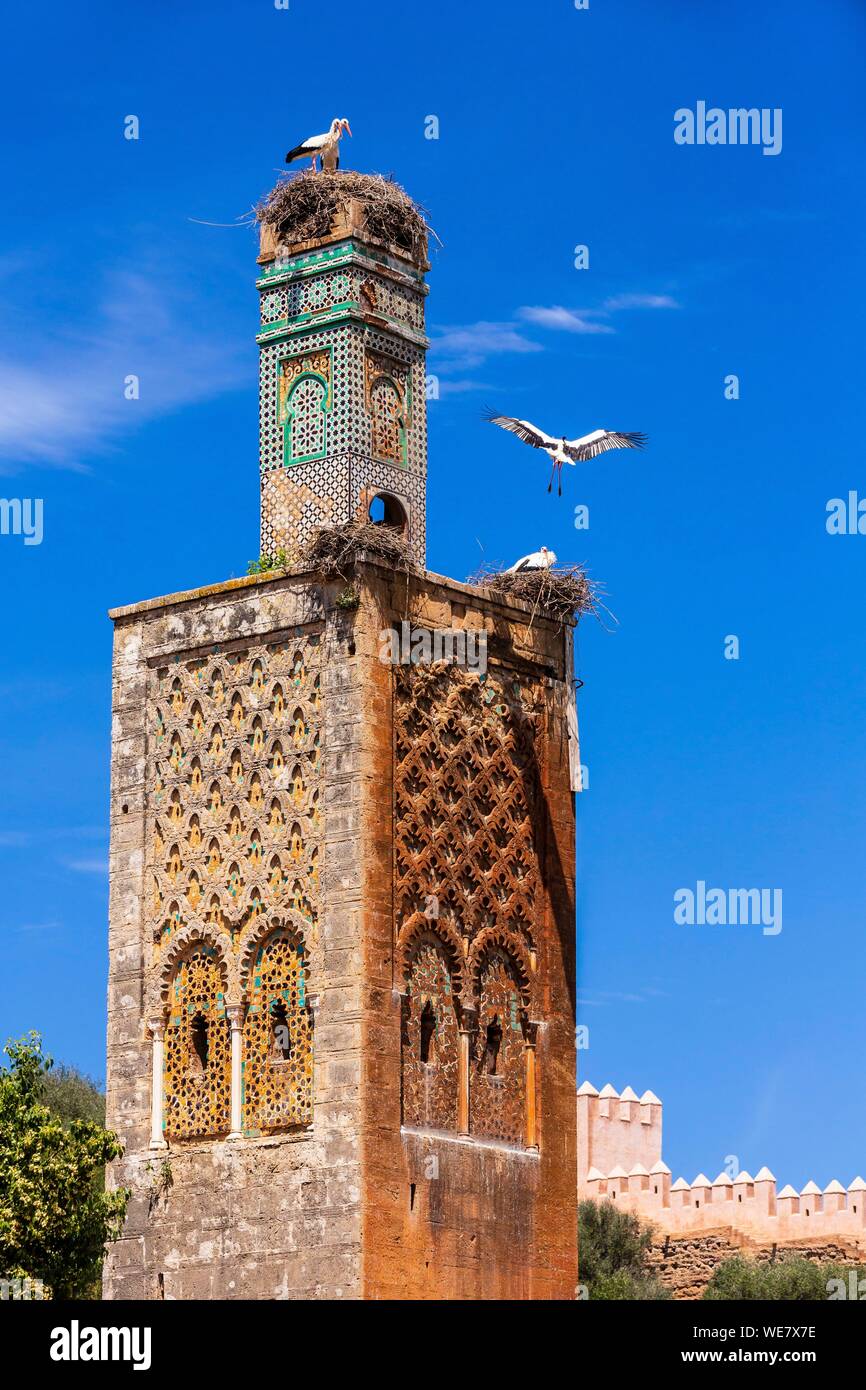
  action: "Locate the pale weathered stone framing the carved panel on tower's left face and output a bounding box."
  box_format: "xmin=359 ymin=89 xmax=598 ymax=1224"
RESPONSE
xmin=106 ymin=577 xmax=361 ymax=1298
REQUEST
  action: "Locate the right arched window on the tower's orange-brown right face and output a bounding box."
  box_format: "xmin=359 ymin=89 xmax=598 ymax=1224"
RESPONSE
xmin=470 ymin=949 xmax=527 ymax=1144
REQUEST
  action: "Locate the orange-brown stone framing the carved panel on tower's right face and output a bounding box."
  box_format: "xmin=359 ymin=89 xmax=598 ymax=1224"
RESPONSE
xmin=357 ymin=558 xmax=577 ymax=1298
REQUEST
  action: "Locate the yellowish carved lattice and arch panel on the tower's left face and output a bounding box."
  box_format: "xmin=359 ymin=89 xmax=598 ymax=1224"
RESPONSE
xmin=147 ymin=628 xmax=321 ymax=1137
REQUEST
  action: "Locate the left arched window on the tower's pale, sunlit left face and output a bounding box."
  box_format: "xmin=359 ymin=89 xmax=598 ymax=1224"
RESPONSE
xmin=164 ymin=942 xmax=231 ymax=1138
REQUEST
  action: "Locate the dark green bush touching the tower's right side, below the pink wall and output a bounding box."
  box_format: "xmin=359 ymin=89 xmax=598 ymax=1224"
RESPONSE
xmin=577 ymin=1201 xmax=670 ymax=1301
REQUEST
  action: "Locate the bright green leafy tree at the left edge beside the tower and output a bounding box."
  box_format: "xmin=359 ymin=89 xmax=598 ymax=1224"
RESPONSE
xmin=0 ymin=1033 xmax=129 ymax=1298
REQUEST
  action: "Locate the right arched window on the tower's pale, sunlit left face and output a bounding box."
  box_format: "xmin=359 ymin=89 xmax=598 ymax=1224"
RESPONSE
xmin=243 ymin=929 xmax=313 ymax=1134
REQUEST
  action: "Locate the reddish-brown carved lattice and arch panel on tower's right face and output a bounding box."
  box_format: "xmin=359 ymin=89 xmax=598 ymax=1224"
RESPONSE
xmin=395 ymin=664 xmax=541 ymax=1144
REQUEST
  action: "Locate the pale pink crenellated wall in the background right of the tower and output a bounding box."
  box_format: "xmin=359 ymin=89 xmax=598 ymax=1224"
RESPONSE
xmin=577 ymin=1081 xmax=866 ymax=1248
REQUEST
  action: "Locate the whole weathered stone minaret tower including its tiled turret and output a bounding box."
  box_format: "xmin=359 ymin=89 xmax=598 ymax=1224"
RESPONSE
xmin=106 ymin=177 xmax=577 ymax=1298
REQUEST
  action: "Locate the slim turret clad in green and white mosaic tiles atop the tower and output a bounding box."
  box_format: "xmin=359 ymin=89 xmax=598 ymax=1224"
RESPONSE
xmin=257 ymin=174 xmax=428 ymax=567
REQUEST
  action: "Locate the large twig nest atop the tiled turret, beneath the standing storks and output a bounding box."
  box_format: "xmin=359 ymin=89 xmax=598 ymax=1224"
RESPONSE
xmin=256 ymin=170 xmax=428 ymax=261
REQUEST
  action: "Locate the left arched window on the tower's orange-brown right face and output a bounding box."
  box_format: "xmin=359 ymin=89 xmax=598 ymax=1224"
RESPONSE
xmin=402 ymin=934 xmax=459 ymax=1130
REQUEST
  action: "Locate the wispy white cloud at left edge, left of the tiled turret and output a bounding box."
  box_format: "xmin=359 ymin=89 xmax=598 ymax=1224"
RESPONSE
xmin=0 ymin=271 xmax=249 ymax=473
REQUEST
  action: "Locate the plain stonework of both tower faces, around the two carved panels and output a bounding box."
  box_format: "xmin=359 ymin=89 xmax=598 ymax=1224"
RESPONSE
xmin=106 ymin=564 xmax=577 ymax=1298
